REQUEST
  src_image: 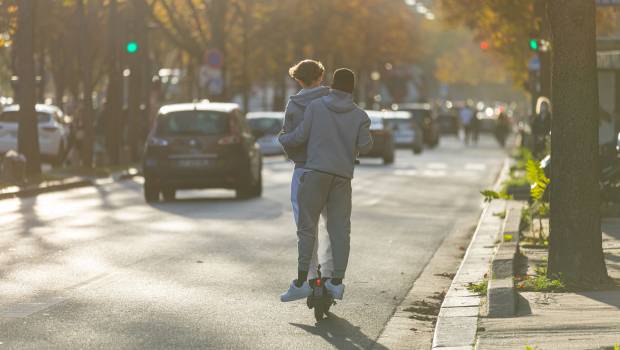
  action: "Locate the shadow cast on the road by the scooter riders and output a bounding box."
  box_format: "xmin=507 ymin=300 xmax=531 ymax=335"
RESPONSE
xmin=291 ymin=312 xmax=388 ymax=350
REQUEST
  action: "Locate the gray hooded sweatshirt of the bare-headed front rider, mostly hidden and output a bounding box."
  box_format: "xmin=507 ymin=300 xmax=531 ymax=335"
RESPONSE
xmin=282 ymin=86 xmax=329 ymax=166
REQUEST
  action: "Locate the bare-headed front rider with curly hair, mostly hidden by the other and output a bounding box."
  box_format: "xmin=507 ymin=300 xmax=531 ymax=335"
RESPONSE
xmin=282 ymin=59 xmax=333 ymax=292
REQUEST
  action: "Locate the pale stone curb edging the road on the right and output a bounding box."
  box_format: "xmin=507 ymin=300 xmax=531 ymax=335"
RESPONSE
xmin=432 ymin=159 xmax=512 ymax=350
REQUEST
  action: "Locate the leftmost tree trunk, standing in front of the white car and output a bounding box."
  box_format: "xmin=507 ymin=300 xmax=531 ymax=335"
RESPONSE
xmin=16 ymin=0 xmax=41 ymax=177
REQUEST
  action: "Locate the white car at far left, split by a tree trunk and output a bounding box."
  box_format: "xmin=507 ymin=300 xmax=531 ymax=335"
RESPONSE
xmin=0 ymin=104 xmax=70 ymax=164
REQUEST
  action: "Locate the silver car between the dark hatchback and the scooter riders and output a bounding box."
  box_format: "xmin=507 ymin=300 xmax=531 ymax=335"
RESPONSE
xmin=246 ymin=112 xmax=284 ymax=156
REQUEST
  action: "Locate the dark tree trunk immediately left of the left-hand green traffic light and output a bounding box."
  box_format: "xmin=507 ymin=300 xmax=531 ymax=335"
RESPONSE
xmin=103 ymin=0 xmax=123 ymax=164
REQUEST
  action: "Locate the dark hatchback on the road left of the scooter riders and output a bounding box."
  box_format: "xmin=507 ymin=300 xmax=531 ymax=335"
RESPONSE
xmin=142 ymin=102 xmax=263 ymax=202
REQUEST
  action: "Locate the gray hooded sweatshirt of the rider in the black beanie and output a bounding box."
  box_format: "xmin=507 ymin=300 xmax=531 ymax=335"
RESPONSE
xmin=279 ymin=89 xmax=372 ymax=179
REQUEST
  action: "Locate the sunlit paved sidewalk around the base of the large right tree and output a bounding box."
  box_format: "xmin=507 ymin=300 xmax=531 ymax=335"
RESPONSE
xmin=476 ymin=218 xmax=620 ymax=350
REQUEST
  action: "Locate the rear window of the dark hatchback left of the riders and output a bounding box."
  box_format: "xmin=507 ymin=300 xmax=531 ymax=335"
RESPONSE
xmin=156 ymin=110 xmax=229 ymax=136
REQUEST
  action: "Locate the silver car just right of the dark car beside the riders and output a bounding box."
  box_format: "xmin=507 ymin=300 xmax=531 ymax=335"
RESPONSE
xmin=384 ymin=111 xmax=424 ymax=154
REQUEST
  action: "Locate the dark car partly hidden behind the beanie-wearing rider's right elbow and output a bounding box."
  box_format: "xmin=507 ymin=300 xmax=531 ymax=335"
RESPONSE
xmin=360 ymin=111 xmax=395 ymax=164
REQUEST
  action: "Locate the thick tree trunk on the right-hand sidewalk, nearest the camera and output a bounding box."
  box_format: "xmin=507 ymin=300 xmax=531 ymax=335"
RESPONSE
xmin=547 ymin=0 xmax=607 ymax=284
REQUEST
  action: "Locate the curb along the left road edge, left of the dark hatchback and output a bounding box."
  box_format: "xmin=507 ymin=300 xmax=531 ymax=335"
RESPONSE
xmin=0 ymin=168 xmax=140 ymax=200
